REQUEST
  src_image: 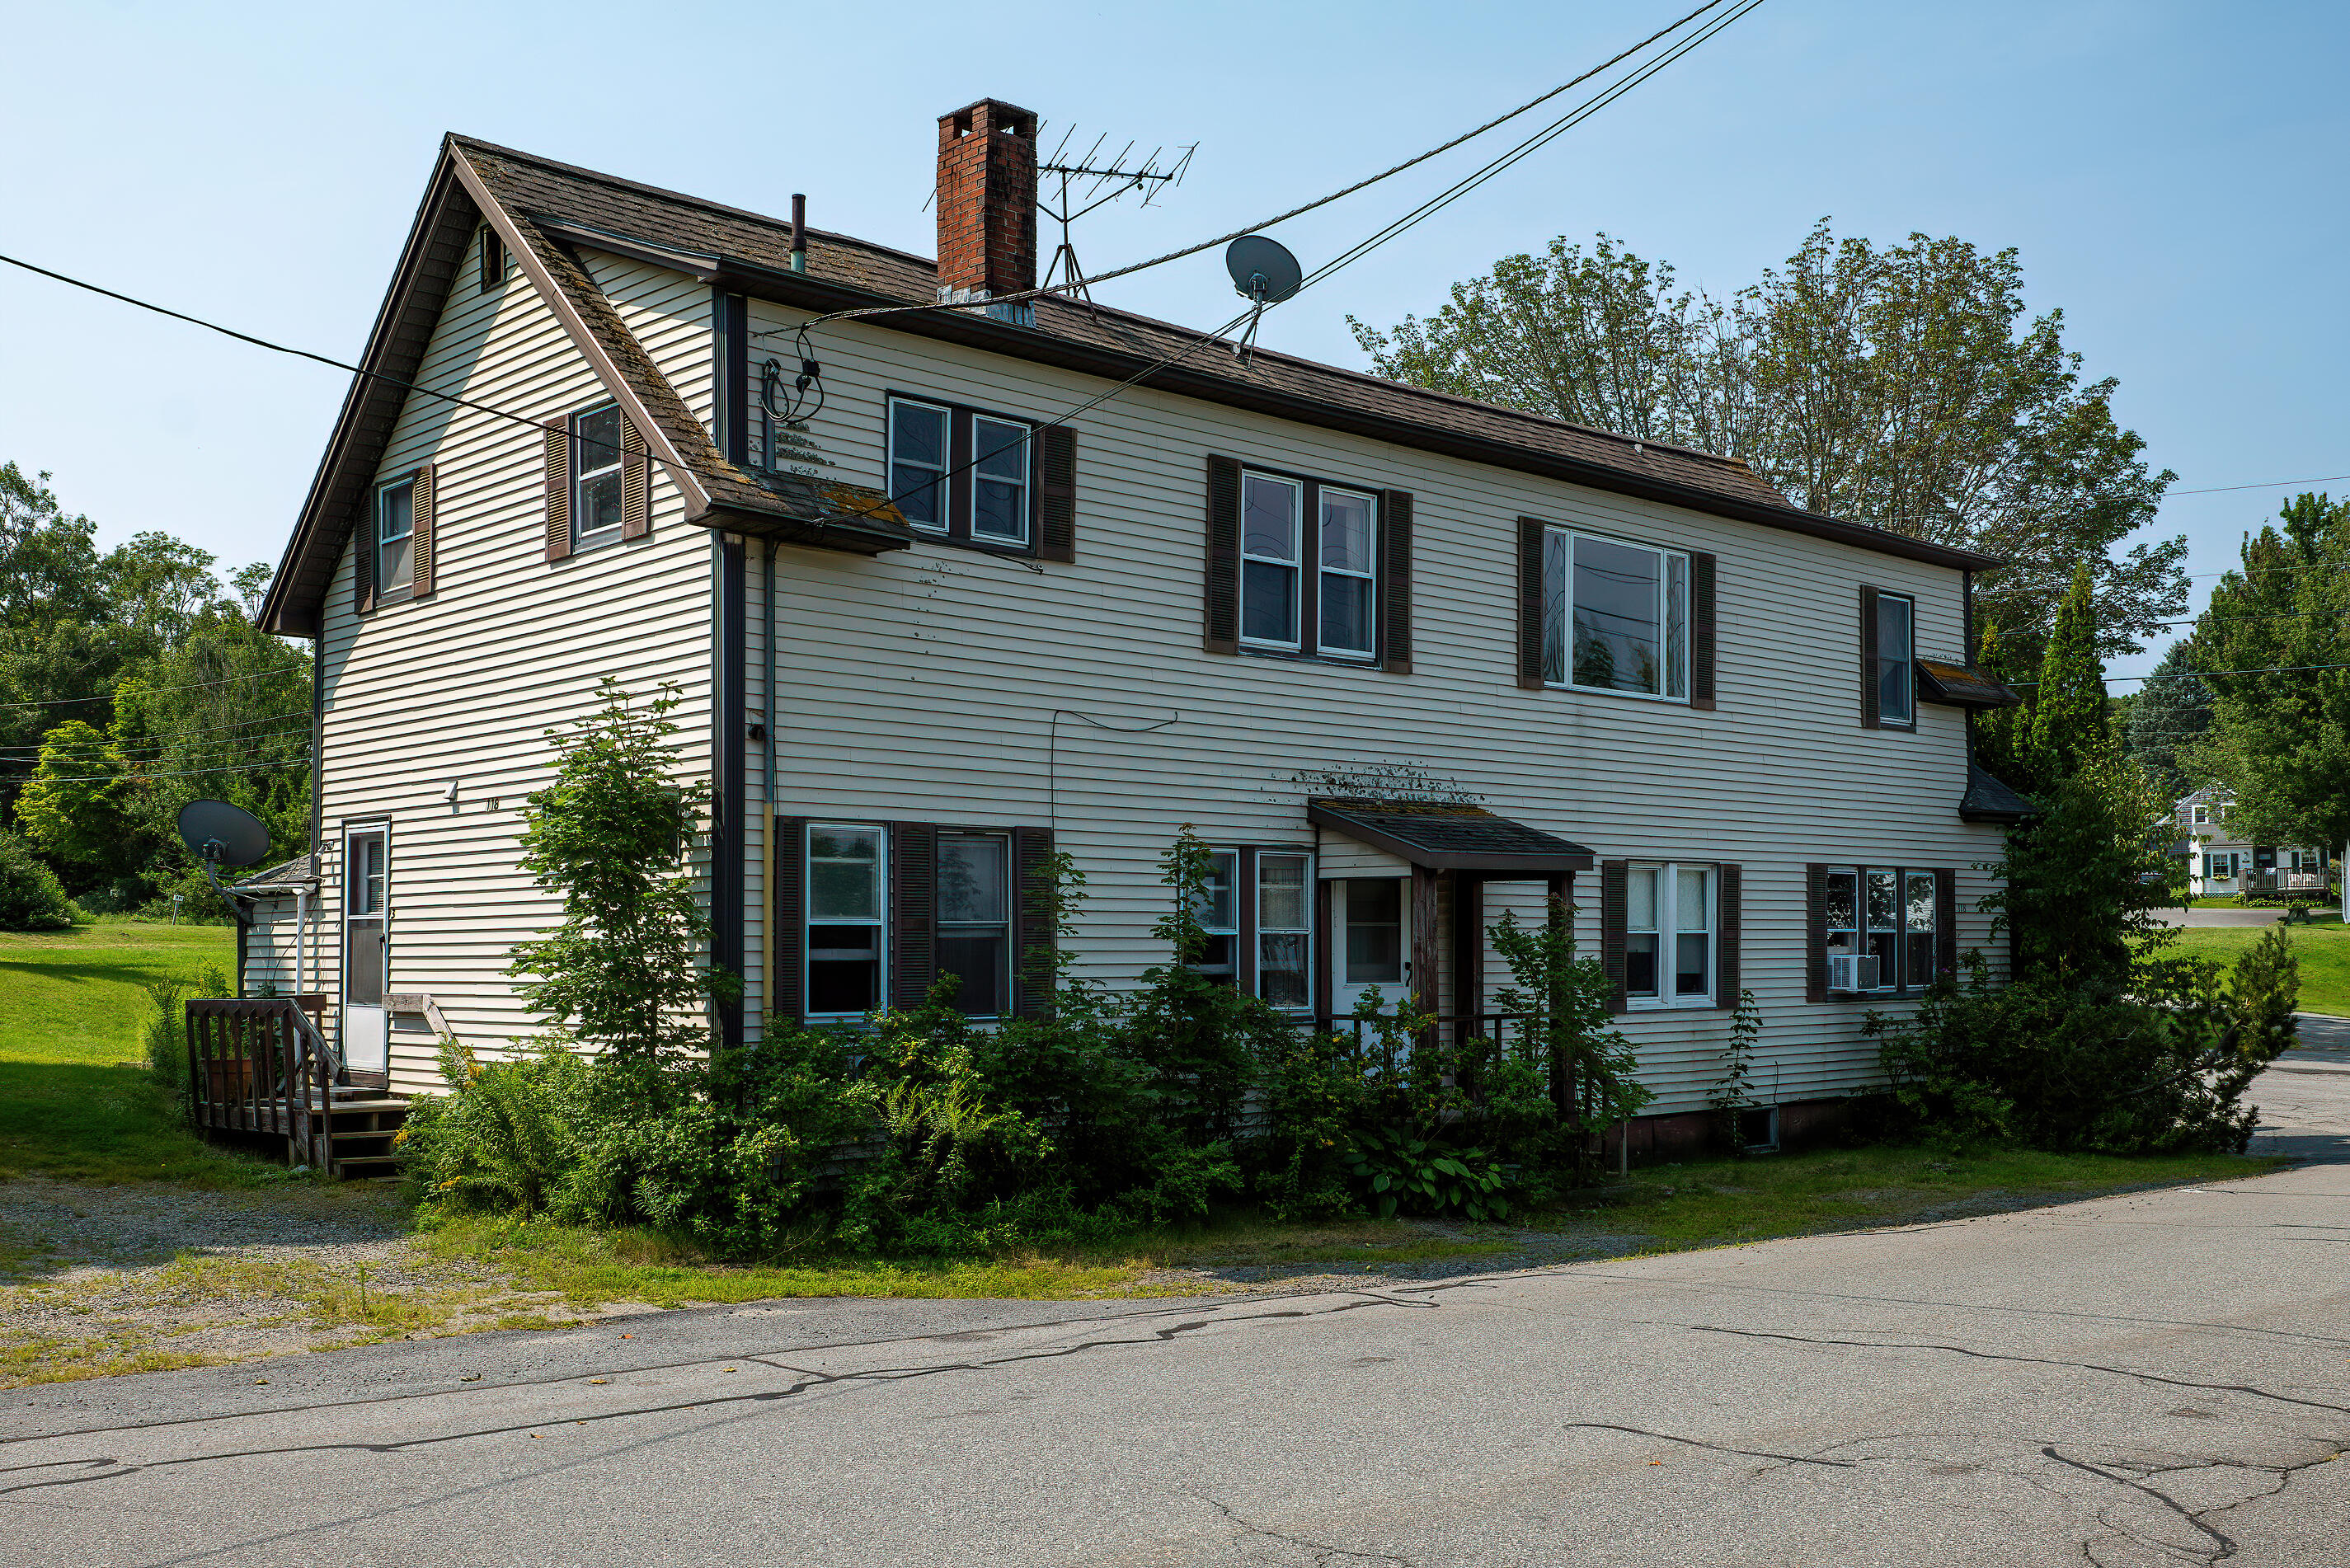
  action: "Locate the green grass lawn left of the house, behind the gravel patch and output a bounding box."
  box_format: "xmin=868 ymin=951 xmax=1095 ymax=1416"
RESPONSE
xmin=0 ymin=922 xmax=286 ymax=1187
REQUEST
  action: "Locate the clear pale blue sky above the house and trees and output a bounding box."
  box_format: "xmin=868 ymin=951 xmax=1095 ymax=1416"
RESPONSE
xmin=0 ymin=0 xmax=2350 ymax=673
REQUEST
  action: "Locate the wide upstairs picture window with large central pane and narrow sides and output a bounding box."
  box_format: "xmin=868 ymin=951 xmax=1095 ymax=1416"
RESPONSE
xmin=1542 ymin=529 xmax=1690 ymax=703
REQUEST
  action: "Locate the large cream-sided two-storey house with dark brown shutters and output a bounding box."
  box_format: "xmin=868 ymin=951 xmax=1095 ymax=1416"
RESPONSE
xmin=249 ymin=101 xmax=2026 ymax=1152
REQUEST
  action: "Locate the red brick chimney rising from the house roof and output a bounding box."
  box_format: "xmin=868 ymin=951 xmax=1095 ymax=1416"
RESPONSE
xmin=938 ymin=99 xmax=1036 ymax=298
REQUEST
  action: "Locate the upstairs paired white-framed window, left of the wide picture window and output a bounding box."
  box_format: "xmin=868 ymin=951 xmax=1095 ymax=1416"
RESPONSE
xmin=1241 ymin=467 xmax=1379 ymax=660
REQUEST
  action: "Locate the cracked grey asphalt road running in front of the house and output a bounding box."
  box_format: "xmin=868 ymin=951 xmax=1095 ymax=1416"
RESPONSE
xmin=0 ymin=1049 xmax=2350 ymax=1568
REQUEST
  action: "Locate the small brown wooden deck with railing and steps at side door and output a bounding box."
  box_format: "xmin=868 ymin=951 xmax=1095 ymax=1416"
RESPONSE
xmin=188 ymin=997 xmax=409 ymax=1176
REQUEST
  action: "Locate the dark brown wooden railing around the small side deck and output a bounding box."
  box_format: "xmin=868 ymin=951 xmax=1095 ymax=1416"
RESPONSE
xmin=188 ymin=997 xmax=343 ymax=1166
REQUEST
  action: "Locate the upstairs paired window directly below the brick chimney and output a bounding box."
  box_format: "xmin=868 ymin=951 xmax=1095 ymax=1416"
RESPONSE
xmin=888 ymin=397 xmax=1036 ymax=550
